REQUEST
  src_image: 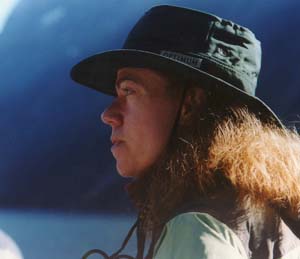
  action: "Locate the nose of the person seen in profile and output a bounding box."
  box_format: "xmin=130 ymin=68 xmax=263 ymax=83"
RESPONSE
xmin=101 ymin=100 xmax=123 ymax=128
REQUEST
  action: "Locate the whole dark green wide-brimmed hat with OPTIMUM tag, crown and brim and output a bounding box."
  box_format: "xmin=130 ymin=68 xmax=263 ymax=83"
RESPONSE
xmin=71 ymin=5 xmax=282 ymax=126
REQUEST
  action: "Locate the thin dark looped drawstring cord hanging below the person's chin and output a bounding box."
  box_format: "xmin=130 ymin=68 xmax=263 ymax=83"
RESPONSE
xmin=82 ymin=220 xmax=139 ymax=259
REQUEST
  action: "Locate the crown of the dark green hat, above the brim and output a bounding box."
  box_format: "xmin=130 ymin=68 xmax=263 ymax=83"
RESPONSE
xmin=123 ymin=5 xmax=261 ymax=95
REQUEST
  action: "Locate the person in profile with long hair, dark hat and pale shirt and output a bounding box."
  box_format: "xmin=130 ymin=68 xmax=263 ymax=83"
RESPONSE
xmin=72 ymin=6 xmax=300 ymax=259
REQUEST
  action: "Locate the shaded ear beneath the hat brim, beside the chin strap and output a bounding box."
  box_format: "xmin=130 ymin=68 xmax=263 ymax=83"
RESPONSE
xmin=180 ymin=87 xmax=206 ymax=124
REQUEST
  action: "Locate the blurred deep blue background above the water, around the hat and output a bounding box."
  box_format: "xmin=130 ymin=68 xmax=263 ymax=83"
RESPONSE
xmin=0 ymin=0 xmax=300 ymax=215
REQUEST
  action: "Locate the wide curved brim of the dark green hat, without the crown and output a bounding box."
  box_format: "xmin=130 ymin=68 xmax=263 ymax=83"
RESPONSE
xmin=71 ymin=49 xmax=283 ymax=127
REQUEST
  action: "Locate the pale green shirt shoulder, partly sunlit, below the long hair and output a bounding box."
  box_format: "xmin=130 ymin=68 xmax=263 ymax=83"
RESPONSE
xmin=154 ymin=212 xmax=248 ymax=259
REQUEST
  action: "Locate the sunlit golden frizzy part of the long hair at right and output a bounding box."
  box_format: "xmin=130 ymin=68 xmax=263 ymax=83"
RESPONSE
xmin=207 ymin=109 xmax=300 ymax=218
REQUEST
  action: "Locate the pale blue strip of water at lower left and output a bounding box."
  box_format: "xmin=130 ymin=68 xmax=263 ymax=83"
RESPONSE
xmin=0 ymin=210 xmax=136 ymax=259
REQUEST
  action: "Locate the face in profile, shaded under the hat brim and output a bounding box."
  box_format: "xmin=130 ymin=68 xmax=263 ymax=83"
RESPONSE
xmin=101 ymin=67 xmax=180 ymax=178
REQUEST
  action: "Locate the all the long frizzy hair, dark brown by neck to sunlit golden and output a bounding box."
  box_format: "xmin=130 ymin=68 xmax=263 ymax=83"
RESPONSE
xmin=128 ymin=83 xmax=300 ymax=234
